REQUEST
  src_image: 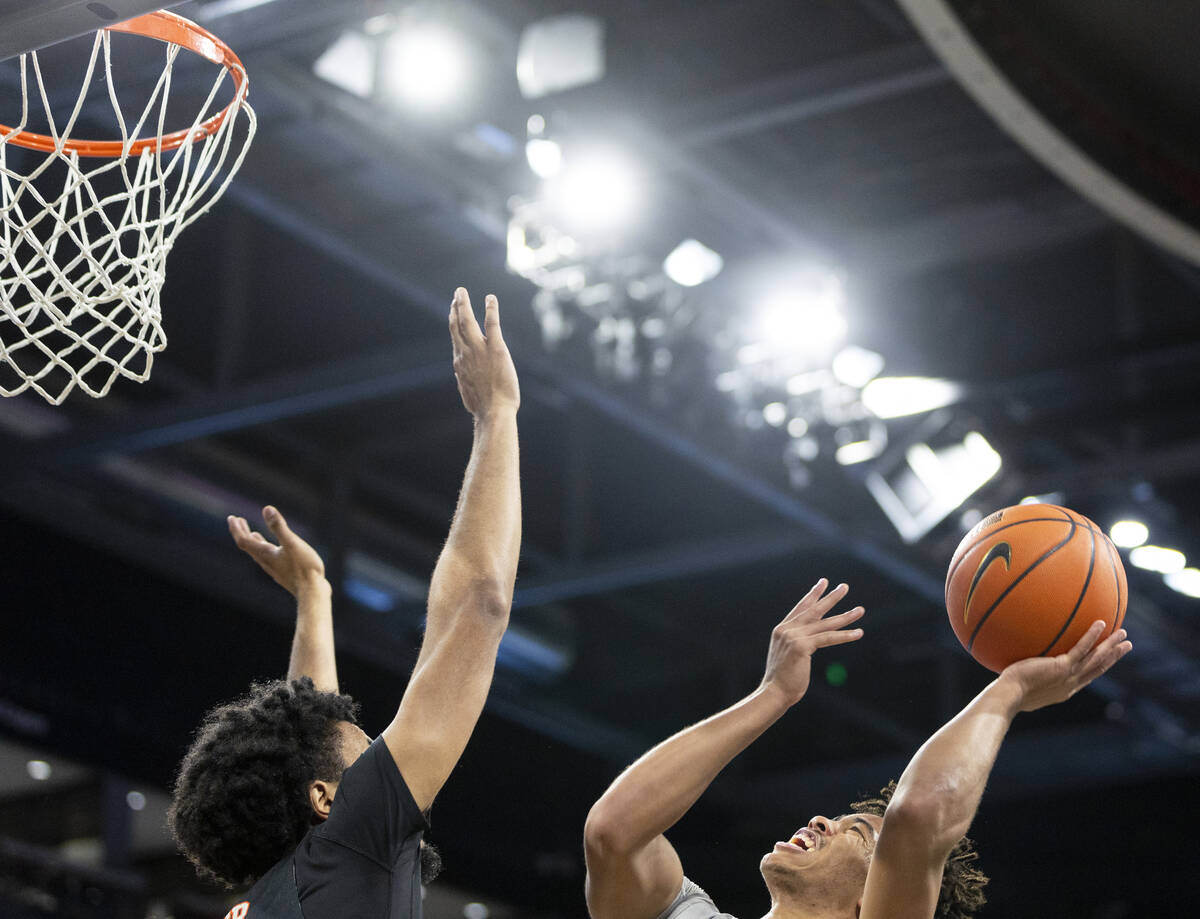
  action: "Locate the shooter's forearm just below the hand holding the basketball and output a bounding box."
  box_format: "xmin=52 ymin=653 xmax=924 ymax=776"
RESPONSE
xmin=889 ymin=679 xmax=1021 ymax=851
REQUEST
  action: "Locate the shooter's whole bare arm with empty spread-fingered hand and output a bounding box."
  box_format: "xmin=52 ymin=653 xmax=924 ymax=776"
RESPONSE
xmin=583 ymin=579 xmax=863 ymax=919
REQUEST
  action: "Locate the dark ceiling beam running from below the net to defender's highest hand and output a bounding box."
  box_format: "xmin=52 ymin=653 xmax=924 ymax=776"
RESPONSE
xmin=0 ymin=342 xmax=450 ymax=473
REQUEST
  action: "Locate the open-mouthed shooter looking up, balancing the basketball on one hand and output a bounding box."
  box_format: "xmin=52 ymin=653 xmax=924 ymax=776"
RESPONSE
xmin=583 ymin=578 xmax=1130 ymax=919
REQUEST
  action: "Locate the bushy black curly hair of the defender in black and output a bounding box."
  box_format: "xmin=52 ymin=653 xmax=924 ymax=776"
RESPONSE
xmin=167 ymin=677 xmax=358 ymax=887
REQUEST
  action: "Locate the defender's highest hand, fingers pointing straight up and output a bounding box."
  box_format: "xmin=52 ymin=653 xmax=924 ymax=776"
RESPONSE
xmin=450 ymin=287 xmax=521 ymax=420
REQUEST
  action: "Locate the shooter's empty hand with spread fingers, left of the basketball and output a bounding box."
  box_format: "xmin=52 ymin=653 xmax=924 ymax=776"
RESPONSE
xmin=762 ymin=578 xmax=864 ymax=704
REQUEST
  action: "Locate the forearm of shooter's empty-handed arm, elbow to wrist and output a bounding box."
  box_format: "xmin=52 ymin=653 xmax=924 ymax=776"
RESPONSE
xmin=586 ymin=685 xmax=788 ymax=852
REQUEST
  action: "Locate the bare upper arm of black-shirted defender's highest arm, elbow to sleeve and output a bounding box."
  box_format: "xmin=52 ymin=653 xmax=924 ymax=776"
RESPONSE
xmin=383 ymin=612 xmax=504 ymax=810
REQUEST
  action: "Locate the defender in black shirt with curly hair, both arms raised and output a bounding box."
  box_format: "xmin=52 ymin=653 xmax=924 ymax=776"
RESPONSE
xmin=168 ymin=288 xmax=521 ymax=919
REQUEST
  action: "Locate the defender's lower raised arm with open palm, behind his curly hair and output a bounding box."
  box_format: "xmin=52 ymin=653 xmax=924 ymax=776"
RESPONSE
xmin=228 ymin=506 xmax=337 ymax=692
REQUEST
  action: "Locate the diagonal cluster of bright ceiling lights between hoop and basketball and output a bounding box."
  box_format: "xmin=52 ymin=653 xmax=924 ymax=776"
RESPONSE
xmin=314 ymin=4 xmax=1000 ymax=541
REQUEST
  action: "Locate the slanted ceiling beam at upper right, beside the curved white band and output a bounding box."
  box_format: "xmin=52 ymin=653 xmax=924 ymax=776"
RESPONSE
xmin=667 ymin=42 xmax=950 ymax=148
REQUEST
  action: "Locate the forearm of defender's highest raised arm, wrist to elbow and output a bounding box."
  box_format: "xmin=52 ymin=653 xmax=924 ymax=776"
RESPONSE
xmin=426 ymin=408 xmax=521 ymax=641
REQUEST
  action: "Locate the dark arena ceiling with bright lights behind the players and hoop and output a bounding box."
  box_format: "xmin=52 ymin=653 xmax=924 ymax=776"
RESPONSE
xmin=0 ymin=0 xmax=1200 ymax=919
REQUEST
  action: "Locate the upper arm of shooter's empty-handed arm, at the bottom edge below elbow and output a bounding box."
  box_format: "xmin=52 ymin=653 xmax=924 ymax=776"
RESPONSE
xmin=584 ymin=835 xmax=683 ymax=919
